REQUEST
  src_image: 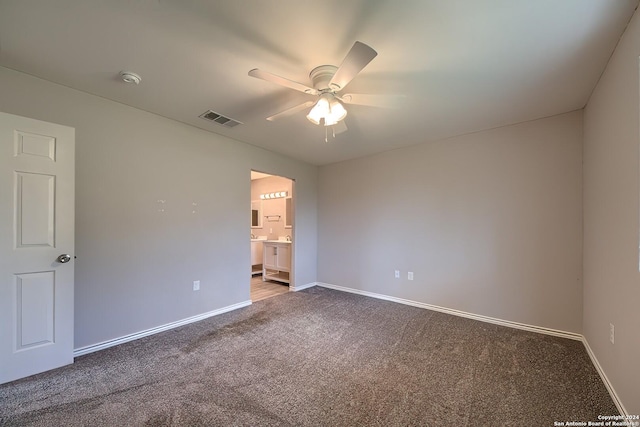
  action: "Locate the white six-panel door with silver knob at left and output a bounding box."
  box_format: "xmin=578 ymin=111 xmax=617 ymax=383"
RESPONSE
xmin=0 ymin=113 xmax=75 ymax=384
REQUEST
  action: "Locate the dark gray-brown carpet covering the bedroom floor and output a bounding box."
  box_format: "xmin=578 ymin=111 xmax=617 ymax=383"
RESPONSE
xmin=0 ymin=288 xmax=618 ymax=426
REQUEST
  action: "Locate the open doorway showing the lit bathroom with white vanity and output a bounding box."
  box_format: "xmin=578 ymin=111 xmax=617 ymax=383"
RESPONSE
xmin=250 ymin=170 xmax=295 ymax=302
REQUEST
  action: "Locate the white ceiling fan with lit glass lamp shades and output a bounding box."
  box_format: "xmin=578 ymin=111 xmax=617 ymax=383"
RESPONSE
xmin=249 ymin=41 xmax=403 ymax=135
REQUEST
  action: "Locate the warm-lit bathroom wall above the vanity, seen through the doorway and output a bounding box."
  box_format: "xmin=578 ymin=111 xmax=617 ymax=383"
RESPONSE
xmin=251 ymin=176 xmax=293 ymax=239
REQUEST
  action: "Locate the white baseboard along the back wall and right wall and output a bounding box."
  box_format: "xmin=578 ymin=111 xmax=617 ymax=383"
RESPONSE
xmin=316 ymin=282 xmax=629 ymax=416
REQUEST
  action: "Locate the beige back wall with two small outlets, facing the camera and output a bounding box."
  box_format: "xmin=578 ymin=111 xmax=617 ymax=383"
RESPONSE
xmin=318 ymin=111 xmax=582 ymax=333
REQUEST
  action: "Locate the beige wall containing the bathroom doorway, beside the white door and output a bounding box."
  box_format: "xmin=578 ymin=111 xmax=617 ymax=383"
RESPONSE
xmin=0 ymin=68 xmax=317 ymax=348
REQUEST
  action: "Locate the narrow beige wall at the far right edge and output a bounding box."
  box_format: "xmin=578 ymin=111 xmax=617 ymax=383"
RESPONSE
xmin=583 ymin=6 xmax=640 ymax=414
